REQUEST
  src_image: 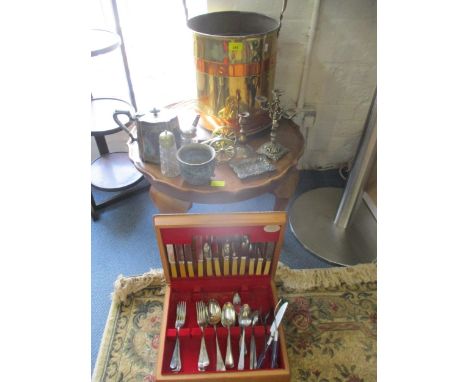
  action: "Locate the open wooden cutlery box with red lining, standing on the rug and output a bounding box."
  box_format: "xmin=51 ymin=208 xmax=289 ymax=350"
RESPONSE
xmin=154 ymin=212 xmax=290 ymax=382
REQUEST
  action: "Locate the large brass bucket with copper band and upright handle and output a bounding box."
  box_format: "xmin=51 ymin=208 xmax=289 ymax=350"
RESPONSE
xmin=183 ymin=0 xmax=287 ymax=135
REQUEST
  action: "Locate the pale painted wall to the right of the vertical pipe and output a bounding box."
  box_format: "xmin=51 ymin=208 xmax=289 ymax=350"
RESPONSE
xmin=302 ymin=0 xmax=377 ymax=168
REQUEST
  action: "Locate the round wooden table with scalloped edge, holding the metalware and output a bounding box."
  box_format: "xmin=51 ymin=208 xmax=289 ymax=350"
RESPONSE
xmin=128 ymin=120 xmax=304 ymax=213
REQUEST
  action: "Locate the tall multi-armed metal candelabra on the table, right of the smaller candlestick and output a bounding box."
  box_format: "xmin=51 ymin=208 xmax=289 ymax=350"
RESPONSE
xmin=256 ymin=89 xmax=289 ymax=161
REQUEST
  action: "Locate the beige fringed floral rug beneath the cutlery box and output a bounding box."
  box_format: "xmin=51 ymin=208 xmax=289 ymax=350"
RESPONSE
xmin=93 ymin=264 xmax=377 ymax=382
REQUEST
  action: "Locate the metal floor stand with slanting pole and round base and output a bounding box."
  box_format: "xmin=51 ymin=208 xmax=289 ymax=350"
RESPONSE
xmin=289 ymin=91 xmax=377 ymax=265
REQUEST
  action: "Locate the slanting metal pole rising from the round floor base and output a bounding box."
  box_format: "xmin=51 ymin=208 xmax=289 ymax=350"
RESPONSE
xmin=333 ymin=90 xmax=377 ymax=229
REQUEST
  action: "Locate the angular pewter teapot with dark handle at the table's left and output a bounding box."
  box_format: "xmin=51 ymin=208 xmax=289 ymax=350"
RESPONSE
xmin=113 ymin=108 xmax=181 ymax=164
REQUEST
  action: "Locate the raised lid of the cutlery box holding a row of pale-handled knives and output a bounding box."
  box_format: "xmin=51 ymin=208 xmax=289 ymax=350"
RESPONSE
xmin=153 ymin=211 xmax=287 ymax=283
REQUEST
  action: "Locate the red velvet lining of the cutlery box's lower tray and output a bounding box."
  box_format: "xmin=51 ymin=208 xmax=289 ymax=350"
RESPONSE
xmin=162 ymin=276 xmax=284 ymax=374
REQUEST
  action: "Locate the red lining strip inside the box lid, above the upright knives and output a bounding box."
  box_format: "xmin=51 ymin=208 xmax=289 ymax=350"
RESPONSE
xmin=160 ymin=226 xmax=280 ymax=245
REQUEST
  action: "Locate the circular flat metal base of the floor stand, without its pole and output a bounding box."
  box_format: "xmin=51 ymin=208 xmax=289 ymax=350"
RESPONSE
xmin=289 ymin=187 xmax=377 ymax=265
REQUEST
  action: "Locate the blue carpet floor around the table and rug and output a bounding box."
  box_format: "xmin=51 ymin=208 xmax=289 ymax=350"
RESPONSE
xmin=91 ymin=170 xmax=345 ymax=369
